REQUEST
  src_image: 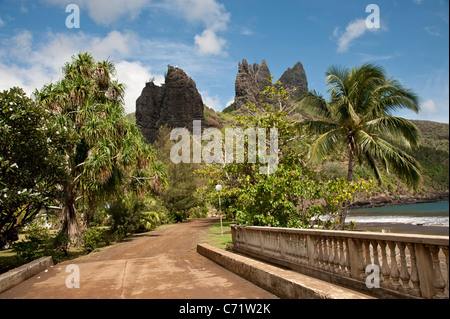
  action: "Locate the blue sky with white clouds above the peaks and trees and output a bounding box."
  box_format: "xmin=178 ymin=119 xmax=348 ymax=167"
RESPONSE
xmin=0 ymin=0 xmax=449 ymax=123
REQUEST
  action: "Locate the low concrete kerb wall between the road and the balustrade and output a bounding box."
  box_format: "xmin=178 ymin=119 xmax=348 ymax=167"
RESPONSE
xmin=197 ymin=244 xmax=373 ymax=299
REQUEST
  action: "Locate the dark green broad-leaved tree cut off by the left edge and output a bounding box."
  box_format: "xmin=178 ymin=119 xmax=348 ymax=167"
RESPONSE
xmin=0 ymin=88 xmax=69 ymax=248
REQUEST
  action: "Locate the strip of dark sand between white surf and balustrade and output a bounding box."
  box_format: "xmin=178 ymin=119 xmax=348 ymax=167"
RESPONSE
xmin=354 ymin=223 xmax=449 ymax=236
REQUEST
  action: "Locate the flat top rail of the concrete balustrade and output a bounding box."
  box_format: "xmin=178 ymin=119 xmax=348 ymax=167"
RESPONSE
xmin=231 ymin=225 xmax=449 ymax=246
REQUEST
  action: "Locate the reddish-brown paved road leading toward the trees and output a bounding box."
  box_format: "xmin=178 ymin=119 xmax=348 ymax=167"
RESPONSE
xmin=0 ymin=219 xmax=276 ymax=299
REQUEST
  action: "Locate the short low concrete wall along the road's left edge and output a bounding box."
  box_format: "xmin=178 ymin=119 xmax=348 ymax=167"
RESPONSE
xmin=0 ymin=256 xmax=53 ymax=294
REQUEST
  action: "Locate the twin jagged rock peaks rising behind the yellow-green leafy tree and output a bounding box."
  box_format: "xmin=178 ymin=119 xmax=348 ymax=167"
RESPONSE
xmin=234 ymin=59 xmax=308 ymax=110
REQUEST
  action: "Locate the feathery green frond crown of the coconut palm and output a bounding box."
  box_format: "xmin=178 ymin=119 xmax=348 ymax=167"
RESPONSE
xmin=301 ymin=64 xmax=421 ymax=189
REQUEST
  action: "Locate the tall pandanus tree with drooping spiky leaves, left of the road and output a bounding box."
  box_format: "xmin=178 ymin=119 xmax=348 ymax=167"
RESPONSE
xmin=35 ymin=53 xmax=161 ymax=240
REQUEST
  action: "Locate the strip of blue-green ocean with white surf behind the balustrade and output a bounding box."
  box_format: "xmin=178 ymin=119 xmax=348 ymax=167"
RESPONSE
xmin=345 ymin=202 xmax=449 ymax=227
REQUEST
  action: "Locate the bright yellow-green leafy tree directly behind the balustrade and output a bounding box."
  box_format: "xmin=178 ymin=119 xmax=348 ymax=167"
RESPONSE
xmin=199 ymin=83 xmax=370 ymax=228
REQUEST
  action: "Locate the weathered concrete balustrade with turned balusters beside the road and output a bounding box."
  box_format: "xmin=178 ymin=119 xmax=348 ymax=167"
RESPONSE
xmin=231 ymin=225 xmax=449 ymax=299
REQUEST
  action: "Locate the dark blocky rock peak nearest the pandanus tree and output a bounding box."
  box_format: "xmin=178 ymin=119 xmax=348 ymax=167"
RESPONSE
xmin=136 ymin=67 xmax=204 ymax=143
